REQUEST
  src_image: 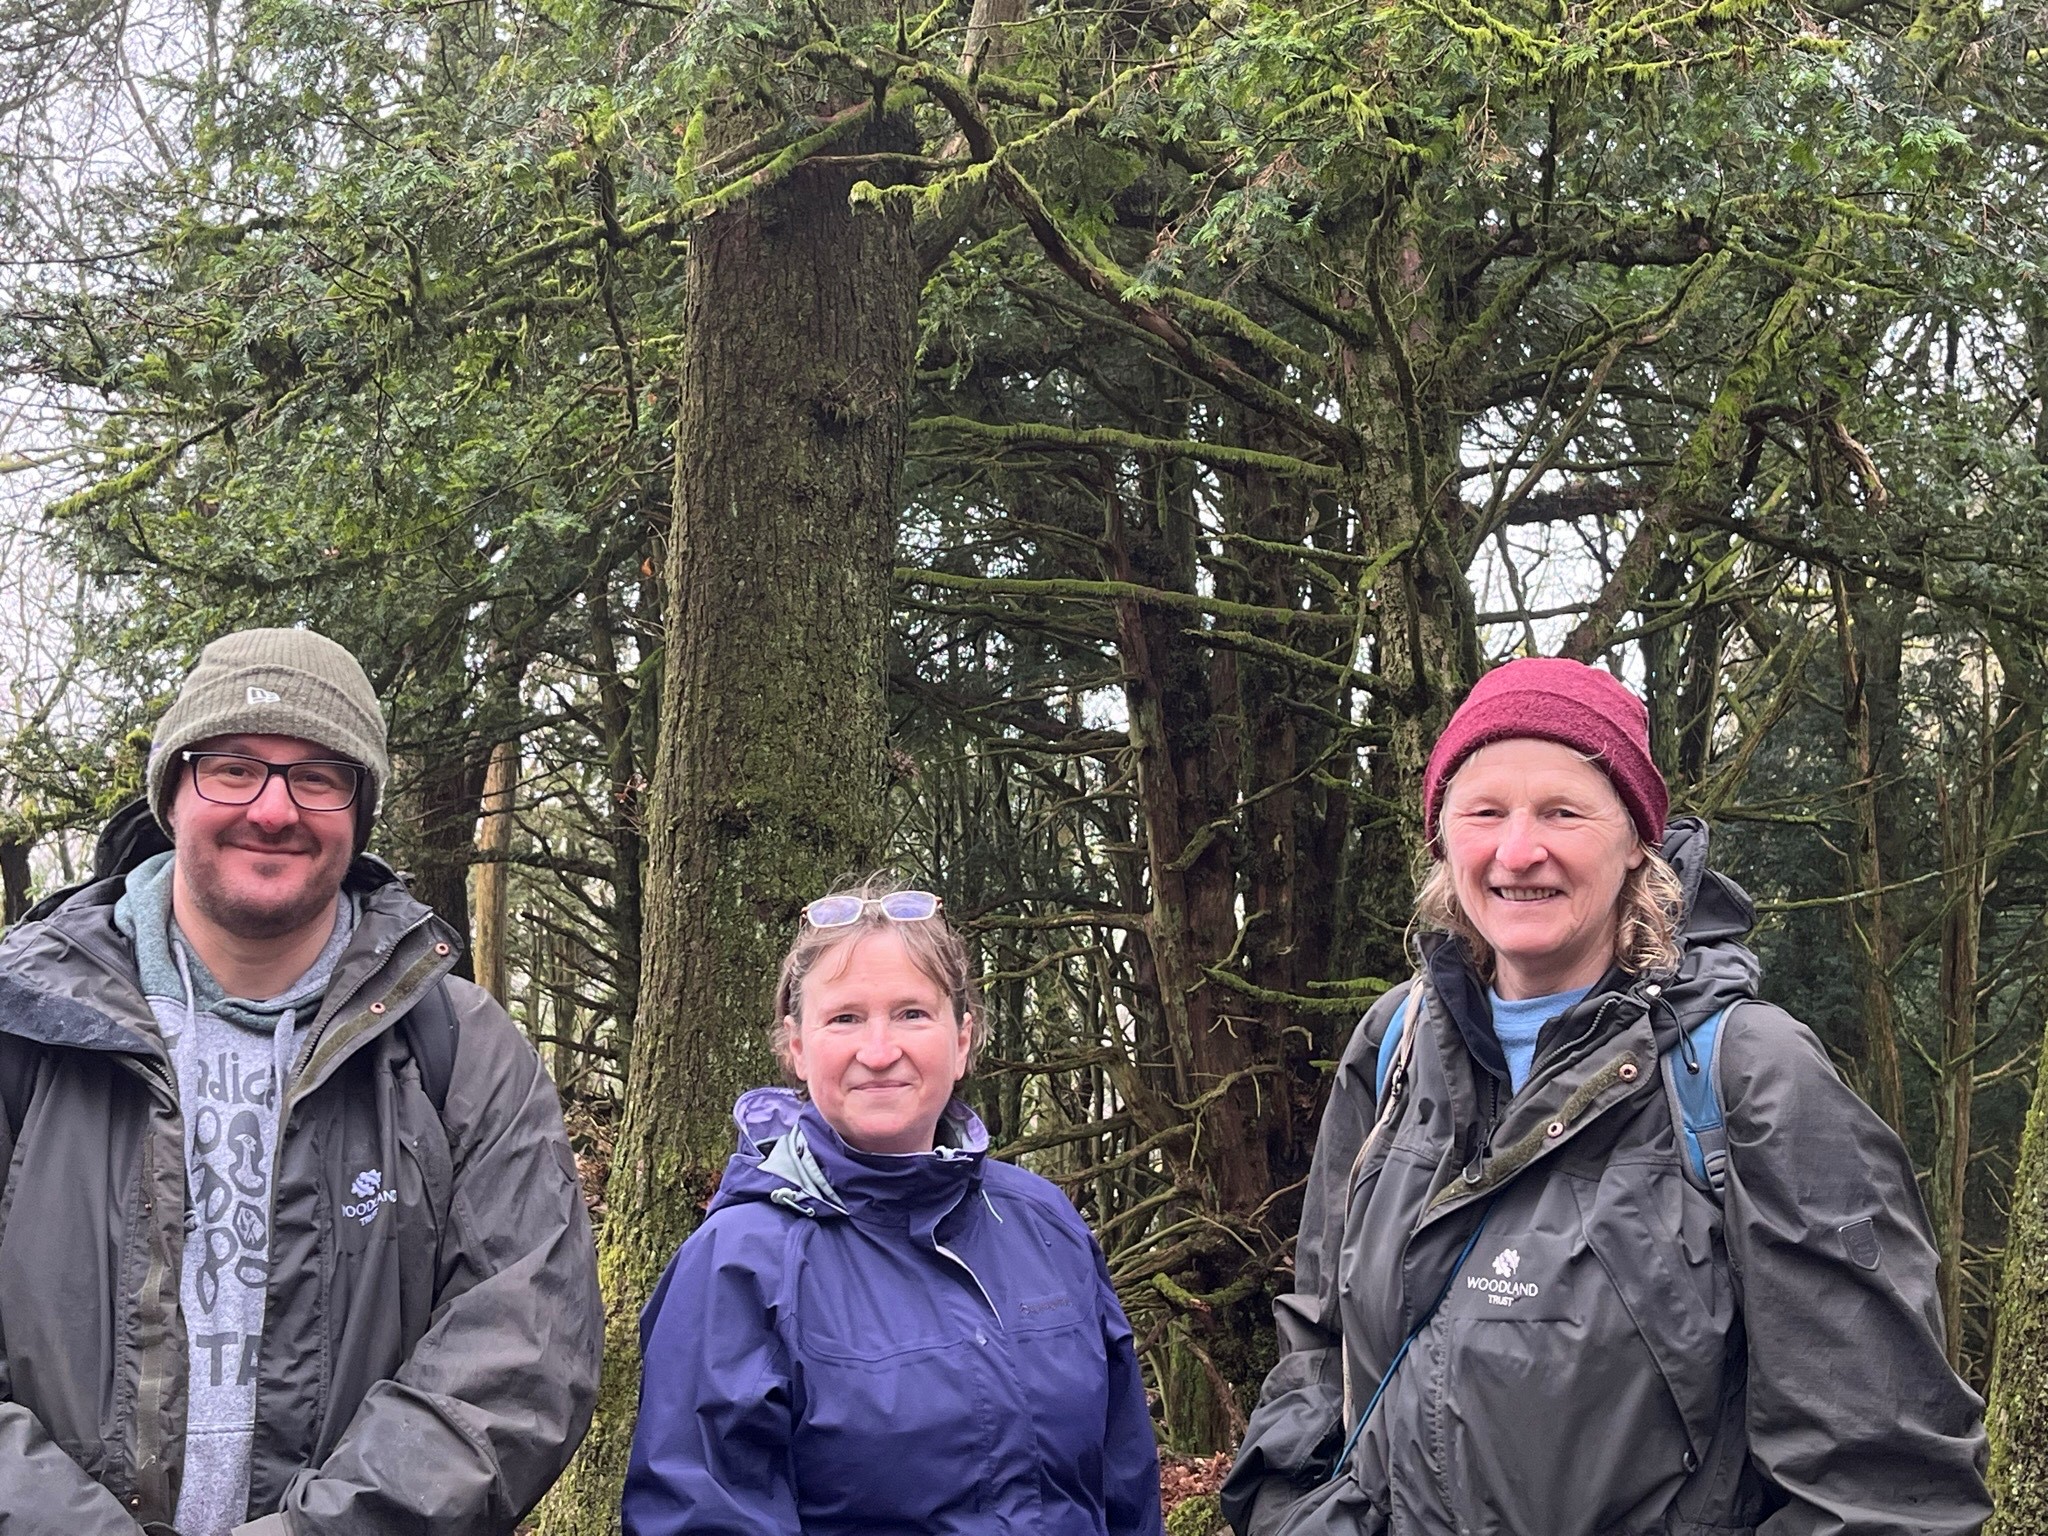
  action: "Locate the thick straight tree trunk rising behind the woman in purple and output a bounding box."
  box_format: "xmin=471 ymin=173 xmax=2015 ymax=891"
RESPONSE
xmin=543 ymin=111 xmax=918 ymax=1534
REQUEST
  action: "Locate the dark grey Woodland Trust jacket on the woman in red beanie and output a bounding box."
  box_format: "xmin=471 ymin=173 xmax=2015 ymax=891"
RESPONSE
xmin=1225 ymin=821 xmax=1991 ymax=1536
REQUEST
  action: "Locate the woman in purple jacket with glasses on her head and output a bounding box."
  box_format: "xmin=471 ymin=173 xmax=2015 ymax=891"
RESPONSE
xmin=623 ymin=879 xmax=1161 ymax=1536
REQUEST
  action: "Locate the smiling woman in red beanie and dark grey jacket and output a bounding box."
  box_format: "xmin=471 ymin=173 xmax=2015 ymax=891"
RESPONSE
xmin=1223 ymin=659 xmax=1991 ymax=1536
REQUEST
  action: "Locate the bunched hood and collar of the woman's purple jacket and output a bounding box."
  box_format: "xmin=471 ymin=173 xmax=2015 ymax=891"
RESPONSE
xmin=711 ymin=1087 xmax=989 ymax=1231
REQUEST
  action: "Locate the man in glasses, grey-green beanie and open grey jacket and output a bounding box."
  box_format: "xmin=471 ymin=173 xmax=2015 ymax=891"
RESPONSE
xmin=0 ymin=629 xmax=604 ymax=1536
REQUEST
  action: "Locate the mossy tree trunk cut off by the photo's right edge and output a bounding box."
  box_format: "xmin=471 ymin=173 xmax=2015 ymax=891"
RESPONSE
xmin=1985 ymin=1028 xmax=2048 ymax=1536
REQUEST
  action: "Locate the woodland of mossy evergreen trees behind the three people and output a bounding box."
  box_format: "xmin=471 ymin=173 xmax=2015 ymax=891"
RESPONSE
xmin=0 ymin=0 xmax=2048 ymax=1534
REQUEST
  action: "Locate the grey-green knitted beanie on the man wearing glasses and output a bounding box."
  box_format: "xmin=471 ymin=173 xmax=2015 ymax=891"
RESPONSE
xmin=150 ymin=629 xmax=391 ymax=848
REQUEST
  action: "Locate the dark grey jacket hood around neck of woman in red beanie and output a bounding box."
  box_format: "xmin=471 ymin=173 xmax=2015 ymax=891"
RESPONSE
xmin=1419 ymin=815 xmax=1763 ymax=1081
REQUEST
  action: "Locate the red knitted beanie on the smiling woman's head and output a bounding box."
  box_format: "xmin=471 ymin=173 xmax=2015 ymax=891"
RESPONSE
xmin=1421 ymin=655 xmax=1671 ymax=856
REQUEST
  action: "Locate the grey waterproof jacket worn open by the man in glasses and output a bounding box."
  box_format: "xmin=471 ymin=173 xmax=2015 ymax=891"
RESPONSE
xmin=0 ymin=860 xmax=604 ymax=1536
